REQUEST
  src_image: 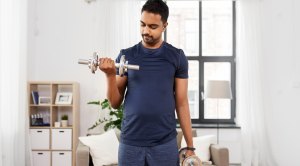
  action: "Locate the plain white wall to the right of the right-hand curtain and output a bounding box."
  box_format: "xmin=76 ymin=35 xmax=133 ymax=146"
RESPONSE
xmin=261 ymin=0 xmax=300 ymax=166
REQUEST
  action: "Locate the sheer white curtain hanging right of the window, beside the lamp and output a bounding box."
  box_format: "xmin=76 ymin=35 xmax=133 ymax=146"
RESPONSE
xmin=237 ymin=0 xmax=276 ymax=166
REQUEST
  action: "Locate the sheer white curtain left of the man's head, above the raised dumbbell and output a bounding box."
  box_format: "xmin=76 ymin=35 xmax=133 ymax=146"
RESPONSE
xmin=96 ymin=0 xmax=141 ymax=58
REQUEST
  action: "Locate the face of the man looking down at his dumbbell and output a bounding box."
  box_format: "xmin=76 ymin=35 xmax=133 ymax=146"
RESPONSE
xmin=140 ymin=11 xmax=167 ymax=47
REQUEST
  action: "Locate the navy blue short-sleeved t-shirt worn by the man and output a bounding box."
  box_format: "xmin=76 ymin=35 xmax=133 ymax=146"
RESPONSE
xmin=116 ymin=42 xmax=188 ymax=146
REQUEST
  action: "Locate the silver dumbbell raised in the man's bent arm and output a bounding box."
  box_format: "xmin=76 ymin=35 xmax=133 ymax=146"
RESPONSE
xmin=78 ymin=52 xmax=140 ymax=76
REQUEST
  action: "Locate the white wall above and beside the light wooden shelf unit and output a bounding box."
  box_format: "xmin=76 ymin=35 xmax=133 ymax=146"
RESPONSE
xmin=28 ymin=0 xmax=106 ymax=135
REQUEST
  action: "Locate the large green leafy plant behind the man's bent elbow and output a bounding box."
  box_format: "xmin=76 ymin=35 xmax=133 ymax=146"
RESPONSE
xmin=88 ymin=99 xmax=124 ymax=131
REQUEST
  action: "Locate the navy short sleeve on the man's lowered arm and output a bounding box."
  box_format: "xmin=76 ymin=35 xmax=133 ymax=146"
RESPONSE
xmin=175 ymin=50 xmax=189 ymax=78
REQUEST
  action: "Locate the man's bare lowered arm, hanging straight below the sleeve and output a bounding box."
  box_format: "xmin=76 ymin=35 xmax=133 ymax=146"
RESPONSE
xmin=175 ymin=78 xmax=194 ymax=156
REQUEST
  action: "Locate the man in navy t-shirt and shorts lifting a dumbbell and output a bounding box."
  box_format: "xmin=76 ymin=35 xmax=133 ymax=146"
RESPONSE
xmin=99 ymin=0 xmax=194 ymax=166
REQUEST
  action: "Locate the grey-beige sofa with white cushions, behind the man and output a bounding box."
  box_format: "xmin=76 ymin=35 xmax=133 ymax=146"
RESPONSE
xmin=76 ymin=130 xmax=229 ymax=166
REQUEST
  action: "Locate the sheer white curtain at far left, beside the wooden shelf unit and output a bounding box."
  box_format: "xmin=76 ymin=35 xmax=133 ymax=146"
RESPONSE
xmin=0 ymin=0 xmax=27 ymax=166
